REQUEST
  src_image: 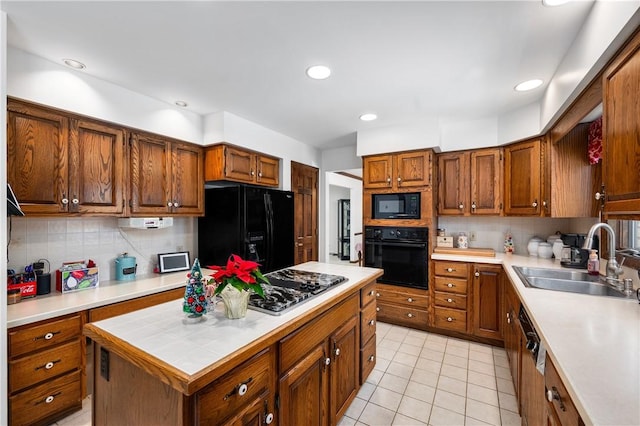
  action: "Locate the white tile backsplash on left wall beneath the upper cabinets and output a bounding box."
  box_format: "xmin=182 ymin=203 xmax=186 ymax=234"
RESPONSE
xmin=7 ymin=217 xmax=198 ymax=281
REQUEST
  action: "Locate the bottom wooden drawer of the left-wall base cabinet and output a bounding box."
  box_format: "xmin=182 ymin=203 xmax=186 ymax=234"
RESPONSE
xmin=9 ymin=371 xmax=82 ymax=425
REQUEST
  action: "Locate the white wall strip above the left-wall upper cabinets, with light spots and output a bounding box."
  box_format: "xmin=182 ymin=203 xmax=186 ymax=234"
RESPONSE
xmin=3 ymin=47 xmax=202 ymax=144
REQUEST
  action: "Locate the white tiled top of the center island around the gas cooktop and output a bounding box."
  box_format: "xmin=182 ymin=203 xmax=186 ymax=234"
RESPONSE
xmin=80 ymin=262 xmax=382 ymax=381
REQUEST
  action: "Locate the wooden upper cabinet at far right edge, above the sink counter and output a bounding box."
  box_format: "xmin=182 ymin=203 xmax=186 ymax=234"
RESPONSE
xmin=602 ymin=29 xmax=640 ymax=213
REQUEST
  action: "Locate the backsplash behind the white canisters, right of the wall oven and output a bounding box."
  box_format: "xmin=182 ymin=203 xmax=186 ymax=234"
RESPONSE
xmin=438 ymin=216 xmax=597 ymax=256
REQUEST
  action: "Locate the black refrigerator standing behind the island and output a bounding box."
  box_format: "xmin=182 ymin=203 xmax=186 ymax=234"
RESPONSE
xmin=198 ymin=185 xmax=294 ymax=273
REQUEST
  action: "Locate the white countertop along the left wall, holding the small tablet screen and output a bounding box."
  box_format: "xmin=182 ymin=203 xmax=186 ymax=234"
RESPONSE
xmin=7 ymin=268 xmax=204 ymax=328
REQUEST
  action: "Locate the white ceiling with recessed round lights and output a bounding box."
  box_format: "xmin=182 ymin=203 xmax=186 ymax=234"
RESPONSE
xmin=1 ymin=0 xmax=593 ymax=148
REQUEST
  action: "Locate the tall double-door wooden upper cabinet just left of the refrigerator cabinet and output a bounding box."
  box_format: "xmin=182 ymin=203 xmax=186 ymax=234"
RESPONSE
xmin=130 ymin=133 xmax=204 ymax=216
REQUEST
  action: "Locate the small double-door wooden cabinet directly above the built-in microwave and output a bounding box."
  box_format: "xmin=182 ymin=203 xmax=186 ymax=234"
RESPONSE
xmin=363 ymin=150 xmax=431 ymax=189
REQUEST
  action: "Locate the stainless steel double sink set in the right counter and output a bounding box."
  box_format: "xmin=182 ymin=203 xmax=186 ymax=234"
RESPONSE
xmin=513 ymin=266 xmax=627 ymax=297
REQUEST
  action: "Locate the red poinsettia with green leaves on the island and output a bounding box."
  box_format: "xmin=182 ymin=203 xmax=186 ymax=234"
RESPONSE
xmin=208 ymin=254 xmax=269 ymax=297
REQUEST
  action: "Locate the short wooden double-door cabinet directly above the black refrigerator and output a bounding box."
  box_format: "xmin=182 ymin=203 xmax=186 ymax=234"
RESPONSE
xmin=204 ymin=144 xmax=280 ymax=186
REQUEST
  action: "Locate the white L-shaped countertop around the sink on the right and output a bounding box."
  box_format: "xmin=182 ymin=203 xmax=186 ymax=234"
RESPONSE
xmin=431 ymin=254 xmax=640 ymax=425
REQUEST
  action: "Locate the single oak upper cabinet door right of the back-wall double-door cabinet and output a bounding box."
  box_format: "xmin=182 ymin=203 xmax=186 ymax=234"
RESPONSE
xmin=504 ymin=139 xmax=541 ymax=215
